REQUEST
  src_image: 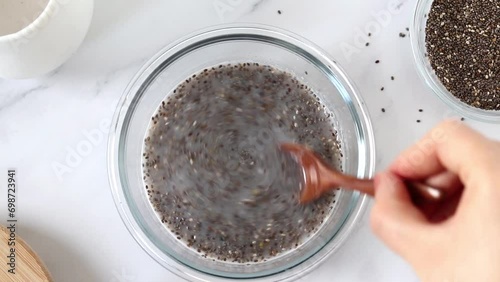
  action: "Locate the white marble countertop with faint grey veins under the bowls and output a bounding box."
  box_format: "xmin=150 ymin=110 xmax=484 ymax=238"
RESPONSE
xmin=0 ymin=0 xmax=500 ymax=282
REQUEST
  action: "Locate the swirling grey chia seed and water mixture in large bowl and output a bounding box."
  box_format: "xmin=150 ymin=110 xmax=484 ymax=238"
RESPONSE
xmin=143 ymin=63 xmax=341 ymax=263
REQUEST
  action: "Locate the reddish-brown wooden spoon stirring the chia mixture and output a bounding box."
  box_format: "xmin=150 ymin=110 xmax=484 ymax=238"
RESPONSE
xmin=280 ymin=143 xmax=445 ymax=206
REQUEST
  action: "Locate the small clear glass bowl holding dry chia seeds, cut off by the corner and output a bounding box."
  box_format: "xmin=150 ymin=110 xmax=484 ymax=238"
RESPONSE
xmin=411 ymin=0 xmax=500 ymax=123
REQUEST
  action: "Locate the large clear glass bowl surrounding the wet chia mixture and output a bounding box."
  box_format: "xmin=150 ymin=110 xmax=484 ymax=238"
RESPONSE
xmin=108 ymin=25 xmax=375 ymax=281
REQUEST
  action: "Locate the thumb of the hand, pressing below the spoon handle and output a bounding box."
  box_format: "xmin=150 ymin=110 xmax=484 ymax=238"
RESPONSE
xmin=371 ymin=173 xmax=436 ymax=260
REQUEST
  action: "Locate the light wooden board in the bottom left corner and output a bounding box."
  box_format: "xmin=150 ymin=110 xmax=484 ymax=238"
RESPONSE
xmin=0 ymin=226 xmax=53 ymax=282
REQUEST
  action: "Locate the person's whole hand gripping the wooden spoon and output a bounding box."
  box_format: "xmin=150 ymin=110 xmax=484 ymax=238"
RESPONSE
xmin=371 ymin=121 xmax=500 ymax=282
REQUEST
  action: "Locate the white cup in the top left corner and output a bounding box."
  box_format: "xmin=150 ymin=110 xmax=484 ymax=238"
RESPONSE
xmin=0 ymin=0 xmax=94 ymax=79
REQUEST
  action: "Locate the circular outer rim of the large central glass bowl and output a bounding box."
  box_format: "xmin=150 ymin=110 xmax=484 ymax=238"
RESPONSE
xmin=107 ymin=23 xmax=375 ymax=281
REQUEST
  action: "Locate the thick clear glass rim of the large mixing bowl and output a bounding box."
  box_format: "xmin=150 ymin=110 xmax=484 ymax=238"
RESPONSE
xmin=108 ymin=23 xmax=375 ymax=281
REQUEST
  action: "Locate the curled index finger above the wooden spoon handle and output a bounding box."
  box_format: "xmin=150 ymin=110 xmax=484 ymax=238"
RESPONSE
xmin=390 ymin=121 xmax=495 ymax=187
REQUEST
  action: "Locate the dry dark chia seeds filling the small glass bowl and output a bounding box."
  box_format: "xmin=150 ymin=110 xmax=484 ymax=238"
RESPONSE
xmin=426 ymin=0 xmax=500 ymax=110
